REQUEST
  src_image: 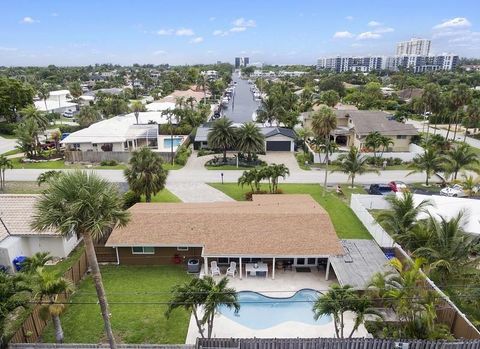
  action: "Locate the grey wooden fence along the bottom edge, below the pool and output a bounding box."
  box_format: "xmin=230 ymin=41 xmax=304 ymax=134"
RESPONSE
xmin=197 ymin=338 xmax=480 ymax=349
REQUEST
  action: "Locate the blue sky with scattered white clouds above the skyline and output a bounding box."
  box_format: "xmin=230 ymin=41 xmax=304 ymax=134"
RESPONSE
xmin=0 ymin=0 xmax=480 ymax=65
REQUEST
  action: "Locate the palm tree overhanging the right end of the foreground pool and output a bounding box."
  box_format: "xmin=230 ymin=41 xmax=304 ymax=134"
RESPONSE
xmin=312 ymin=283 xmax=358 ymax=338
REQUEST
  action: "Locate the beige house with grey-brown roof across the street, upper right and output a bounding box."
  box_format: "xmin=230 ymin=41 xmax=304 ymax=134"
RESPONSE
xmin=302 ymin=110 xmax=418 ymax=152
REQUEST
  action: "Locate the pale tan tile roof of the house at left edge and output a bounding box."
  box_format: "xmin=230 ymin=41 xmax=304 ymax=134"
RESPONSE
xmin=0 ymin=194 xmax=57 ymax=241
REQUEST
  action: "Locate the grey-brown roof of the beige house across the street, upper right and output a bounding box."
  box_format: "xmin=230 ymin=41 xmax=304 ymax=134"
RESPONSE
xmin=335 ymin=110 xmax=418 ymax=136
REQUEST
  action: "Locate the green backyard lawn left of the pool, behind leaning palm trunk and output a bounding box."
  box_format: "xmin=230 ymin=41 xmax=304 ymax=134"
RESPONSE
xmin=43 ymin=265 xmax=190 ymax=344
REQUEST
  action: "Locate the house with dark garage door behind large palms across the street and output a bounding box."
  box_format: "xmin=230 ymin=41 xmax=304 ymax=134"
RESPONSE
xmin=193 ymin=123 xmax=296 ymax=152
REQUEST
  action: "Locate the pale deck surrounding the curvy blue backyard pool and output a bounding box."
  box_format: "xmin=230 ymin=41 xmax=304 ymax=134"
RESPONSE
xmin=185 ymin=268 xmax=368 ymax=344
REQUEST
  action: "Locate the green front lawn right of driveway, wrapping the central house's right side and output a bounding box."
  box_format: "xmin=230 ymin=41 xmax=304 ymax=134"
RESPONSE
xmin=210 ymin=183 xmax=372 ymax=239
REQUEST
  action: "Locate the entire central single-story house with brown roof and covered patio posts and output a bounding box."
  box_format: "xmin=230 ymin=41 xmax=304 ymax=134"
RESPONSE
xmin=105 ymin=195 xmax=345 ymax=278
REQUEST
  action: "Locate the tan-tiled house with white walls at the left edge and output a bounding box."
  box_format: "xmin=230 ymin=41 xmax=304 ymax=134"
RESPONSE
xmin=0 ymin=194 xmax=79 ymax=270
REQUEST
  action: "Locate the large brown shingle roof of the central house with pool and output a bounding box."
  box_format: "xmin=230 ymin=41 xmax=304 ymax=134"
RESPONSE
xmin=106 ymin=195 xmax=344 ymax=257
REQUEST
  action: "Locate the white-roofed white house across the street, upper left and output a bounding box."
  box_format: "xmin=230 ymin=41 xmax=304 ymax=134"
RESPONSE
xmin=62 ymin=112 xmax=176 ymax=152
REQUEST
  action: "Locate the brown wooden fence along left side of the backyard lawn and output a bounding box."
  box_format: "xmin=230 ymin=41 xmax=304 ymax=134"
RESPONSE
xmin=10 ymin=252 xmax=88 ymax=343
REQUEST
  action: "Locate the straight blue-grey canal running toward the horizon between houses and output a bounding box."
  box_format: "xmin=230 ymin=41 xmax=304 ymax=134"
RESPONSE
xmin=223 ymin=73 xmax=260 ymax=123
